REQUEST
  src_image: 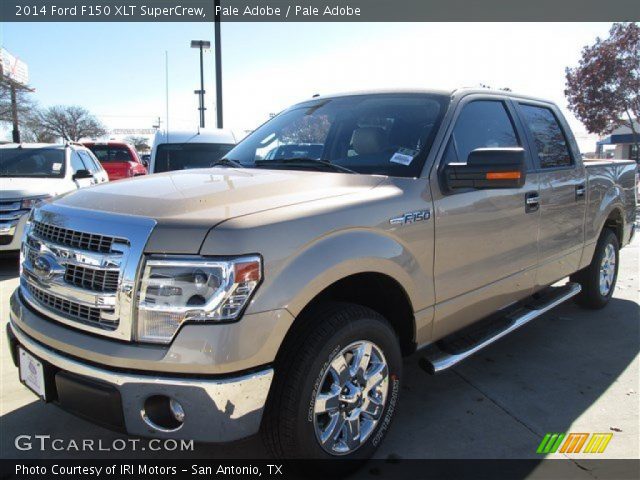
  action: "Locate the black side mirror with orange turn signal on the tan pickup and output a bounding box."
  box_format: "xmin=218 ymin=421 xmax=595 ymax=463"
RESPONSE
xmin=444 ymin=147 xmax=526 ymax=190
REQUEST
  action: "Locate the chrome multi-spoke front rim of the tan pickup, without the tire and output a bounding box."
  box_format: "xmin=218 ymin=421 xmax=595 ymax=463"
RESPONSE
xmin=313 ymin=341 xmax=389 ymax=455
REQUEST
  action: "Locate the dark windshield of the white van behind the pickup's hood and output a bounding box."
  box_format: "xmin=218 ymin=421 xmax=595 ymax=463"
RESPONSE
xmin=153 ymin=143 xmax=233 ymax=173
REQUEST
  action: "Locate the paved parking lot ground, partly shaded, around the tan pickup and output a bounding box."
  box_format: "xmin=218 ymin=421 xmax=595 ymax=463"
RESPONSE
xmin=0 ymin=236 xmax=640 ymax=472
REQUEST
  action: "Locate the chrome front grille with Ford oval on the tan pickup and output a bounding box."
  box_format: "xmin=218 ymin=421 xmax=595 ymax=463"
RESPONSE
xmin=20 ymin=202 xmax=156 ymax=341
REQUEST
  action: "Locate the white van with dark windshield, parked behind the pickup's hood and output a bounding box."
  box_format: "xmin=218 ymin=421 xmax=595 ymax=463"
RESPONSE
xmin=150 ymin=128 xmax=236 ymax=173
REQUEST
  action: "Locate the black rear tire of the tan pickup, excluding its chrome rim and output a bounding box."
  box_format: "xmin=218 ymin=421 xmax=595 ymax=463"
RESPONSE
xmin=571 ymin=229 xmax=620 ymax=310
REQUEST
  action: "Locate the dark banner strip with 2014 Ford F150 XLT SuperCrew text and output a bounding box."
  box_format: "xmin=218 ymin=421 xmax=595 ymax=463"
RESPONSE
xmin=0 ymin=0 xmax=640 ymax=22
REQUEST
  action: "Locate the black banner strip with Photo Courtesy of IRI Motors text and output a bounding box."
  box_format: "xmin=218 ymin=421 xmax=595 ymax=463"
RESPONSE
xmin=0 ymin=459 xmax=640 ymax=480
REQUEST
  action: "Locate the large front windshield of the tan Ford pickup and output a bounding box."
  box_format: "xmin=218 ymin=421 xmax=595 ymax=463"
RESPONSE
xmin=226 ymin=94 xmax=449 ymax=177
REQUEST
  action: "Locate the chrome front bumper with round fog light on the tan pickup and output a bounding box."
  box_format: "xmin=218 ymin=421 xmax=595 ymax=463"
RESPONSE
xmin=7 ymin=322 xmax=273 ymax=443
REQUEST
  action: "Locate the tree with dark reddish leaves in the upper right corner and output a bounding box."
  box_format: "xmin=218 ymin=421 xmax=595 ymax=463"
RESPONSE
xmin=565 ymin=23 xmax=640 ymax=161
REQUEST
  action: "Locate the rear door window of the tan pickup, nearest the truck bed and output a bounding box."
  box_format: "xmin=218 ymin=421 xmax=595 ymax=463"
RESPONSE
xmin=520 ymin=104 xmax=573 ymax=168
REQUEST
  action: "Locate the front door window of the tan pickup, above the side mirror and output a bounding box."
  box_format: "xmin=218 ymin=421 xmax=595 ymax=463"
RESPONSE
xmin=444 ymin=100 xmax=520 ymax=163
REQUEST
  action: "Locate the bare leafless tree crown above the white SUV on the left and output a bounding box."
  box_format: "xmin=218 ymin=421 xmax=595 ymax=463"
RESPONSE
xmin=34 ymin=105 xmax=107 ymax=142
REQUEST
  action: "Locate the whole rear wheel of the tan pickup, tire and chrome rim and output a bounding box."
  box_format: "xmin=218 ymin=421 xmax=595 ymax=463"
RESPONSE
xmin=571 ymin=229 xmax=620 ymax=309
